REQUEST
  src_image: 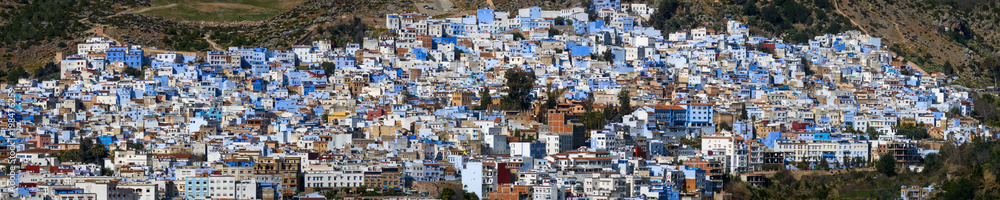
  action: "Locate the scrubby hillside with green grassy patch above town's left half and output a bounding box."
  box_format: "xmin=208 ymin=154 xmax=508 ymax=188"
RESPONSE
xmin=0 ymin=0 xmax=415 ymax=74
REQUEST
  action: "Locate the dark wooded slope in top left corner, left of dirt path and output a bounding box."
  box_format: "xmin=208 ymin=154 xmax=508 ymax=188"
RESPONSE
xmin=0 ymin=0 xmax=148 ymax=76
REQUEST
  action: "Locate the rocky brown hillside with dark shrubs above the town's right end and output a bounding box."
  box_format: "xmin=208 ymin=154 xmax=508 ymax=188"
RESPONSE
xmin=644 ymin=0 xmax=1000 ymax=87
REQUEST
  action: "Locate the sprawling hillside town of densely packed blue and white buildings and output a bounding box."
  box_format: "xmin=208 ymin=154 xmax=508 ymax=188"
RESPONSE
xmin=0 ymin=0 xmax=997 ymax=200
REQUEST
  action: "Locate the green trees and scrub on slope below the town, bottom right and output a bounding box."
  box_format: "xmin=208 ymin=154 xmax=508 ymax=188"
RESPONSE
xmin=726 ymin=139 xmax=1000 ymax=199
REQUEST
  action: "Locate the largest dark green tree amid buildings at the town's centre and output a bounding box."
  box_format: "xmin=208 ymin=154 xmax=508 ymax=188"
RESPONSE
xmin=503 ymin=69 xmax=535 ymax=110
